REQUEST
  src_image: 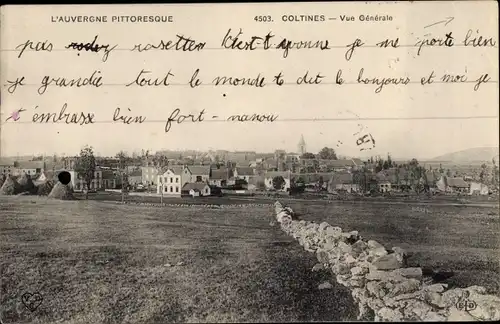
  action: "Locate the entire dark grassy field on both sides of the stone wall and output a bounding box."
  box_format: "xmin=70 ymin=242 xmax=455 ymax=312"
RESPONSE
xmin=0 ymin=197 xmax=500 ymax=323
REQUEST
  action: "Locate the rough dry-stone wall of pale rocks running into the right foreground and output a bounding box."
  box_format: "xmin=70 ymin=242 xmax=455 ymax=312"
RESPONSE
xmin=275 ymin=202 xmax=500 ymax=321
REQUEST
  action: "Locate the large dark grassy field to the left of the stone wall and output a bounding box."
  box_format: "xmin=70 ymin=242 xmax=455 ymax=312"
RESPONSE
xmin=0 ymin=197 xmax=357 ymax=324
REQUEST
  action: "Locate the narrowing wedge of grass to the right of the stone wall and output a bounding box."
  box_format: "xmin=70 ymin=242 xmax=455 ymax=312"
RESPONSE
xmin=289 ymin=202 xmax=500 ymax=296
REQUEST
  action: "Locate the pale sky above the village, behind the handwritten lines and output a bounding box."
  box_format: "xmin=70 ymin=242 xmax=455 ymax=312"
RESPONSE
xmin=0 ymin=2 xmax=499 ymax=158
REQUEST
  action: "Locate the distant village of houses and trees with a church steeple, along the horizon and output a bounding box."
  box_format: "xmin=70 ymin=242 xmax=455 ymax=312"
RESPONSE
xmin=0 ymin=137 xmax=498 ymax=197
